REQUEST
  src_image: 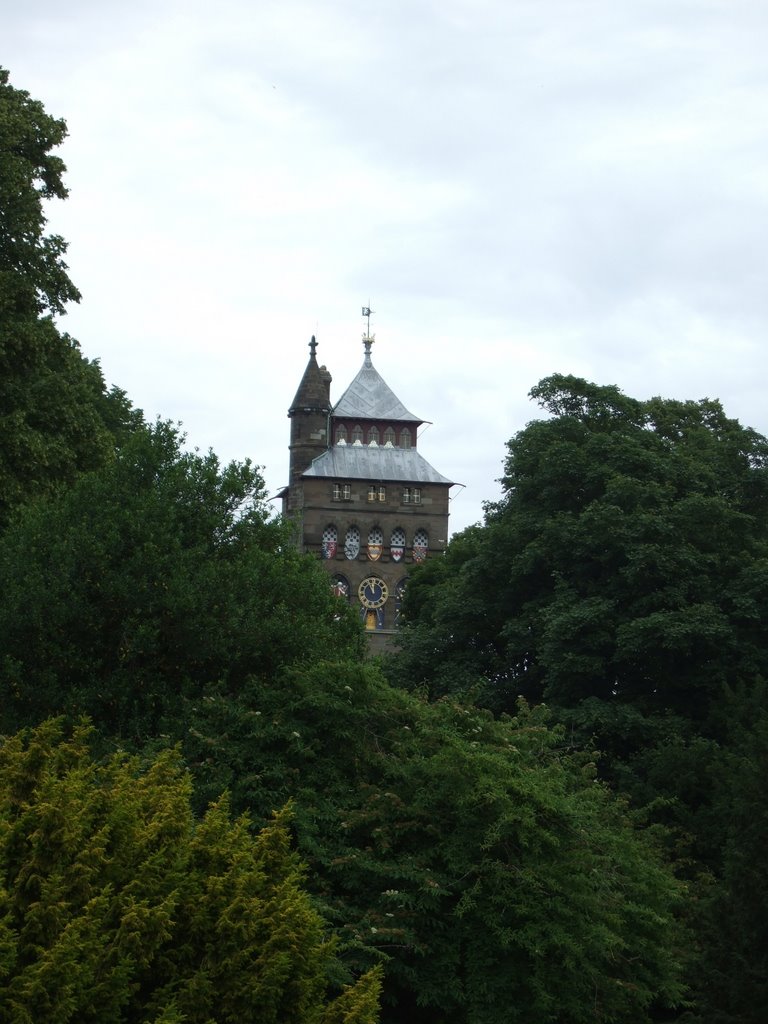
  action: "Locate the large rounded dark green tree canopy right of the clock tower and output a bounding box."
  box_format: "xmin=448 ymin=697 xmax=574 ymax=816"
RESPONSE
xmin=399 ymin=375 xmax=768 ymax=718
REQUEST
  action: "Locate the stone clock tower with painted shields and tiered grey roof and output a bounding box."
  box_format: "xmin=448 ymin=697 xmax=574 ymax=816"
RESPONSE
xmin=281 ymin=321 xmax=454 ymax=650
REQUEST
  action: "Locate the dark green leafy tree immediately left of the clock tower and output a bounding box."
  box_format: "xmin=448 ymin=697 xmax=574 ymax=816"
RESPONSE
xmin=0 ymin=423 xmax=360 ymax=743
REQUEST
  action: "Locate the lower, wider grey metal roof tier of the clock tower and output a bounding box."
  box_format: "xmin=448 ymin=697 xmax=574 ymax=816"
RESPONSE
xmin=303 ymin=444 xmax=455 ymax=486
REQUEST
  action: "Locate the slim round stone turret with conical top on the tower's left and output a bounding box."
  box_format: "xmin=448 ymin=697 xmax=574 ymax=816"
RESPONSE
xmin=284 ymin=335 xmax=331 ymax=515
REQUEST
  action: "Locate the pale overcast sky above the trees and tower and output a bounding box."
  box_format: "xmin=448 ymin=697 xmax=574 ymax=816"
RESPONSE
xmin=6 ymin=0 xmax=768 ymax=530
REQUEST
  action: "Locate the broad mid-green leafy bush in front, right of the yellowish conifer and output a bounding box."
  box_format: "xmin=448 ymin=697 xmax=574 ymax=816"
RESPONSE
xmin=185 ymin=663 xmax=682 ymax=1024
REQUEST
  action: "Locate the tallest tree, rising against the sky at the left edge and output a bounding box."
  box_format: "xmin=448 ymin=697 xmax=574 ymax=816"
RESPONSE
xmin=0 ymin=68 xmax=138 ymax=527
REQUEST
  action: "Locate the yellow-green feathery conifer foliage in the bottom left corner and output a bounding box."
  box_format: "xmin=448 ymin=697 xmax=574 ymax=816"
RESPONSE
xmin=0 ymin=722 xmax=378 ymax=1024
